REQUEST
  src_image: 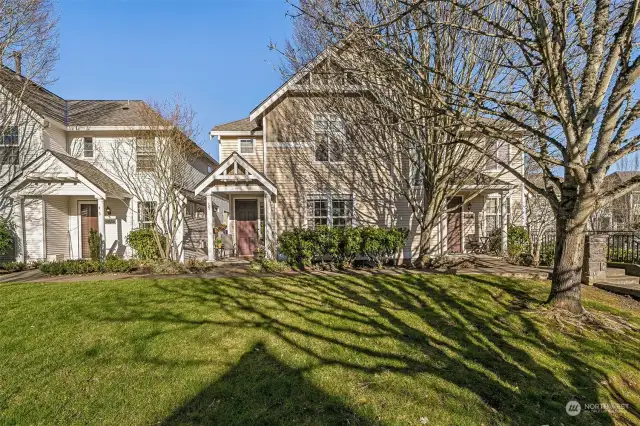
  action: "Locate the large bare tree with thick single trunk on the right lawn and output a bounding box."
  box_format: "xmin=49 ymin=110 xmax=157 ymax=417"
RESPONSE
xmin=292 ymin=0 xmax=640 ymax=313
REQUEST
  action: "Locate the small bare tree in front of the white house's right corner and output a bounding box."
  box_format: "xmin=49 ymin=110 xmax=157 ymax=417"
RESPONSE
xmin=107 ymin=99 xmax=203 ymax=260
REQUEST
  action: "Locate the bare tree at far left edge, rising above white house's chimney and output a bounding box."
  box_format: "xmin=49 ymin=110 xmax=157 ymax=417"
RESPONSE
xmin=0 ymin=0 xmax=57 ymax=257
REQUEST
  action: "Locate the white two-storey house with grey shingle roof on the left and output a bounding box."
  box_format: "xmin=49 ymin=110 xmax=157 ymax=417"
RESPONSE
xmin=0 ymin=63 xmax=228 ymax=261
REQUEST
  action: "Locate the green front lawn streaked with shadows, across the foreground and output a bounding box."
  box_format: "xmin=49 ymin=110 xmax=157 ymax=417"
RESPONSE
xmin=0 ymin=273 xmax=640 ymax=425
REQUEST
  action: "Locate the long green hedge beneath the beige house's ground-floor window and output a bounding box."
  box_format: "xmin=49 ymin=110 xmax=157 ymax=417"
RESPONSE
xmin=278 ymin=226 xmax=408 ymax=268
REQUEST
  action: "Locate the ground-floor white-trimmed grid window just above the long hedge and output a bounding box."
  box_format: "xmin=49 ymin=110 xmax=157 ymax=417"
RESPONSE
xmin=307 ymin=194 xmax=354 ymax=228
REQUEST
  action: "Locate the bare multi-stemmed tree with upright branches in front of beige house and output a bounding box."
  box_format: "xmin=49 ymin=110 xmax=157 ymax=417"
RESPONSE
xmin=283 ymin=2 xmax=518 ymax=259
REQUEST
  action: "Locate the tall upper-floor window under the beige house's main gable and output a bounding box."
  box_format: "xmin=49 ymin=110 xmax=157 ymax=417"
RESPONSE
xmin=313 ymin=114 xmax=346 ymax=162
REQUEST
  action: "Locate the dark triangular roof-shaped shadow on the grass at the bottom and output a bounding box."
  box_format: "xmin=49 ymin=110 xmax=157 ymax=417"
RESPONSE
xmin=161 ymin=343 xmax=374 ymax=426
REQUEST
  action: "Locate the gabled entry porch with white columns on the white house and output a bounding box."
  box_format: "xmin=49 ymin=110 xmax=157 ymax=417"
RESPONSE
xmin=7 ymin=151 xmax=132 ymax=261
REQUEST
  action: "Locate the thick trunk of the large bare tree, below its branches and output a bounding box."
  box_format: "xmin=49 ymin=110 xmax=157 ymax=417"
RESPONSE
xmin=547 ymin=215 xmax=585 ymax=313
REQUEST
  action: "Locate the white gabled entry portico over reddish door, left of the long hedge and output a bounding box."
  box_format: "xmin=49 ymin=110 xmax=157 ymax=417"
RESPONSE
xmin=195 ymin=151 xmax=278 ymax=261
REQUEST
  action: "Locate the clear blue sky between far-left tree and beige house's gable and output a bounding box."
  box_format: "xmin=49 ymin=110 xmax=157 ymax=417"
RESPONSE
xmin=50 ymin=0 xmax=291 ymax=158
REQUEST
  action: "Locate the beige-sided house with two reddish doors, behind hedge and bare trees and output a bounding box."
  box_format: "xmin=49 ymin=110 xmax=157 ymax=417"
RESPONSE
xmin=195 ymin=55 xmax=524 ymax=261
